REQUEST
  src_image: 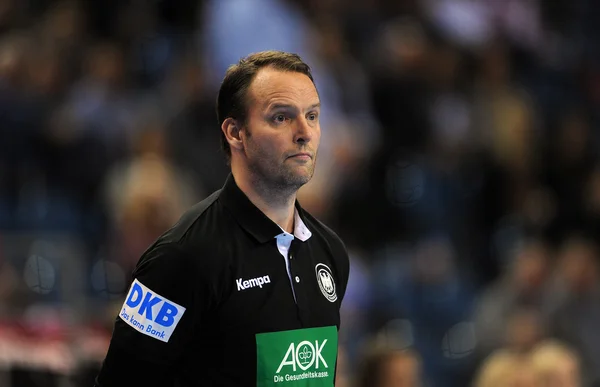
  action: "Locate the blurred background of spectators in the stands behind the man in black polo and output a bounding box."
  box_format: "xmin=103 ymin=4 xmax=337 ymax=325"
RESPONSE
xmin=0 ymin=0 xmax=600 ymax=387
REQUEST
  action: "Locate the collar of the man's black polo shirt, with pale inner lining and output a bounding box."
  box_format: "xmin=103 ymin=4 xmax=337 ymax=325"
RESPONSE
xmin=219 ymin=173 xmax=312 ymax=243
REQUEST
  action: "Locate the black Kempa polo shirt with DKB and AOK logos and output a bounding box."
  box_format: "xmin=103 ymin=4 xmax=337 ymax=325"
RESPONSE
xmin=97 ymin=175 xmax=349 ymax=387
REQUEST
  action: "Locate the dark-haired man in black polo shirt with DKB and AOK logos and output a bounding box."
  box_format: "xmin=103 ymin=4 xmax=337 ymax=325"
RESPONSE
xmin=96 ymin=51 xmax=349 ymax=387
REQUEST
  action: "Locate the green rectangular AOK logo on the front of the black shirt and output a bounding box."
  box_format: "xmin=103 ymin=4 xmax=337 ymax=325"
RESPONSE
xmin=256 ymin=326 xmax=337 ymax=387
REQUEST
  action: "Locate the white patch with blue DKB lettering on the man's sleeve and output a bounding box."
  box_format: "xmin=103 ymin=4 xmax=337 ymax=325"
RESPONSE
xmin=119 ymin=279 xmax=185 ymax=342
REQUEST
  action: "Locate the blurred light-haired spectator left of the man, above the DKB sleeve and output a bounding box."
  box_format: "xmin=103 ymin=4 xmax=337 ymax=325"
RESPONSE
xmin=105 ymin=127 xmax=200 ymax=272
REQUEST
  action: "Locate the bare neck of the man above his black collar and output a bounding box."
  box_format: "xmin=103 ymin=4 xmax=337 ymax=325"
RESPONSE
xmin=231 ymin=165 xmax=296 ymax=234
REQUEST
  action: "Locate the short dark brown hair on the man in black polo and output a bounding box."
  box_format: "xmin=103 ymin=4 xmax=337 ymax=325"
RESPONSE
xmin=217 ymin=51 xmax=315 ymax=161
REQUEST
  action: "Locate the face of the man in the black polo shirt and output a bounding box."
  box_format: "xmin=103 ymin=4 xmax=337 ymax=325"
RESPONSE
xmin=240 ymin=68 xmax=321 ymax=190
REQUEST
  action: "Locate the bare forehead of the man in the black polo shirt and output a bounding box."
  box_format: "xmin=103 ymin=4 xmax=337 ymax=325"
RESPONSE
xmin=248 ymin=67 xmax=319 ymax=108
